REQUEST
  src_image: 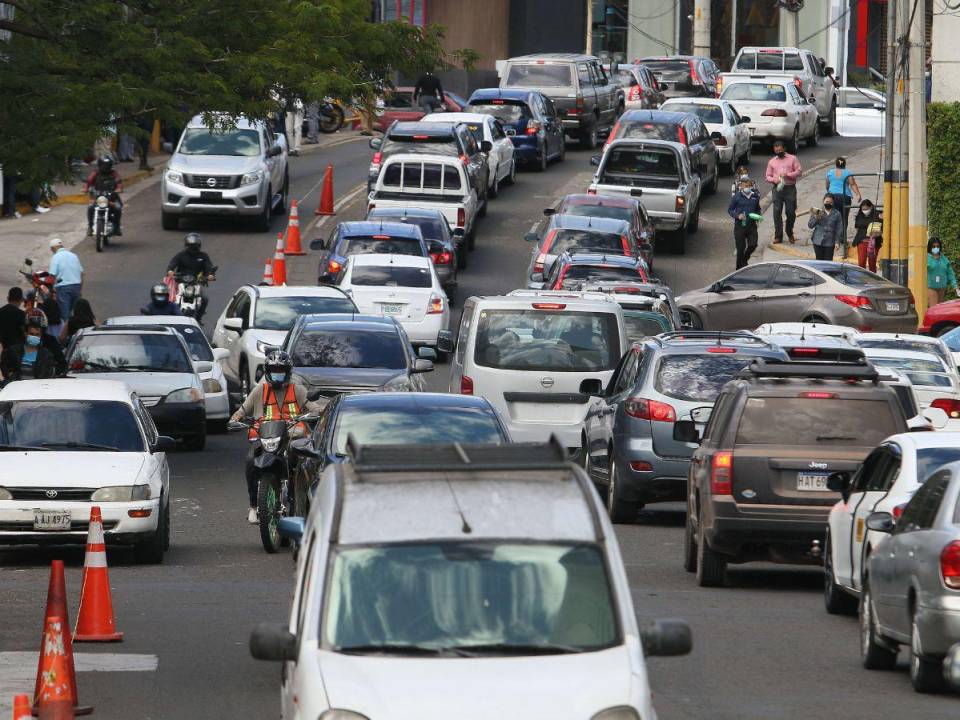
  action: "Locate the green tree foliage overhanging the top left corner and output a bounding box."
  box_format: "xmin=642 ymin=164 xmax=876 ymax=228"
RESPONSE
xmin=0 ymin=0 xmax=458 ymax=181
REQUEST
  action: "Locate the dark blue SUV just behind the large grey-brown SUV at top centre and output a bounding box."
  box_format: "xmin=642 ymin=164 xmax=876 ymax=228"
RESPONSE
xmin=463 ymin=88 xmax=566 ymax=171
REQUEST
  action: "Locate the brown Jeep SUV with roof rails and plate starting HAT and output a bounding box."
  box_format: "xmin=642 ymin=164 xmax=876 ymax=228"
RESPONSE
xmin=674 ymin=360 xmax=907 ymax=587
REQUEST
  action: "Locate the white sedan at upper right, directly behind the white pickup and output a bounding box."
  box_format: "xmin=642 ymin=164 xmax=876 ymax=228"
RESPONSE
xmin=720 ymin=75 xmax=820 ymax=153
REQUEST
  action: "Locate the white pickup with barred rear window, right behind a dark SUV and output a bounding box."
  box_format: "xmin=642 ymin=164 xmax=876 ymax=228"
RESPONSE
xmin=367 ymin=153 xmax=480 ymax=250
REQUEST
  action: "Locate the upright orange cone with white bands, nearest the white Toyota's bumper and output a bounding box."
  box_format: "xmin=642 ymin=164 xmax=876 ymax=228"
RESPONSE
xmin=73 ymin=505 xmax=123 ymax=642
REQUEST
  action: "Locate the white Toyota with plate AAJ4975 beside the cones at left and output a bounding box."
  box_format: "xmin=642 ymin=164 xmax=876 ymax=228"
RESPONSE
xmin=0 ymin=378 xmax=173 ymax=563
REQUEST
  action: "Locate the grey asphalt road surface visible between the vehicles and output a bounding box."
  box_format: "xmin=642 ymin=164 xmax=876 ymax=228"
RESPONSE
xmin=0 ymin=131 xmax=957 ymax=720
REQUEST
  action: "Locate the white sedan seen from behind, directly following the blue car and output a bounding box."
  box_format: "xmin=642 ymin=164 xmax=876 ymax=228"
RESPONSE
xmin=338 ymin=255 xmax=450 ymax=348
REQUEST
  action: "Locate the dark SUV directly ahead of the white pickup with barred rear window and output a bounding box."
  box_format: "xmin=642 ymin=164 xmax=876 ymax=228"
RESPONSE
xmin=367 ymin=121 xmax=493 ymax=200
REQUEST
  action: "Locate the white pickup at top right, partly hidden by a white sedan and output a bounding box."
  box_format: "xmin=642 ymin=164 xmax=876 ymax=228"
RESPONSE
xmin=717 ymin=47 xmax=837 ymax=135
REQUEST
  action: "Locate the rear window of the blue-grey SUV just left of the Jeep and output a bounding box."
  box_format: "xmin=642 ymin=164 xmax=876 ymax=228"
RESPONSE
xmin=656 ymin=350 xmax=756 ymax=403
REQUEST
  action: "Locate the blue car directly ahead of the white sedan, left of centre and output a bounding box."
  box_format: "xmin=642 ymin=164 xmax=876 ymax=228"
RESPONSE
xmin=310 ymin=220 xmax=430 ymax=285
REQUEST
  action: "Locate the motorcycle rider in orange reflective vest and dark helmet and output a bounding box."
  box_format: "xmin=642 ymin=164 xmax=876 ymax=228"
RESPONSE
xmin=230 ymin=350 xmax=323 ymax=525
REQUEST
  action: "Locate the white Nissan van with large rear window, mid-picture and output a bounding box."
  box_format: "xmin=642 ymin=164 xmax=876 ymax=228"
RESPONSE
xmin=438 ymin=290 xmax=629 ymax=456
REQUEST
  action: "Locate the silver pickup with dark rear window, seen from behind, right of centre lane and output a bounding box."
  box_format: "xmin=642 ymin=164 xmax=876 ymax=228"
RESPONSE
xmin=588 ymin=140 xmax=701 ymax=255
